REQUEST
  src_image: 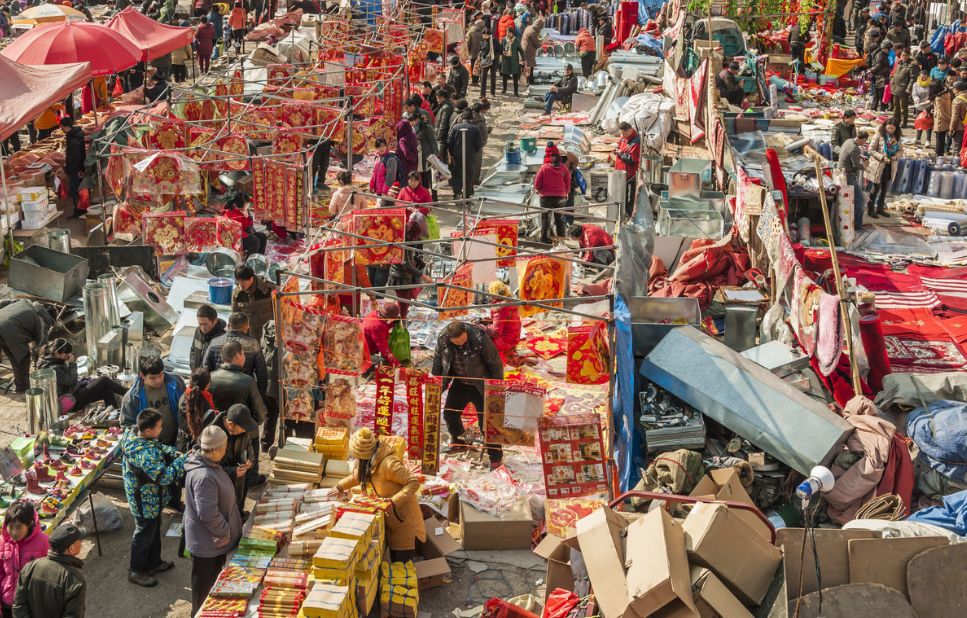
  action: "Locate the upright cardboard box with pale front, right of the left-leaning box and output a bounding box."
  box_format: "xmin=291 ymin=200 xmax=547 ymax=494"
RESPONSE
xmin=624 ymin=509 xmax=698 ymax=617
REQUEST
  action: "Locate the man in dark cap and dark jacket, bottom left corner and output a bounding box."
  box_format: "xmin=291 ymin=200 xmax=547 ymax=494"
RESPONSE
xmin=11 ymin=523 xmax=87 ymax=617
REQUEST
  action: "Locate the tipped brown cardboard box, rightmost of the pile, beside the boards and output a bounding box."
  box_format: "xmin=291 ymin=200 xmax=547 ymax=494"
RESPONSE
xmin=682 ymin=503 xmax=782 ymax=605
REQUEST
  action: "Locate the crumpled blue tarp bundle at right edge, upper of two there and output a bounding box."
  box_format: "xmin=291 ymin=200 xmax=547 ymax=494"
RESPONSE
xmin=907 ymin=400 xmax=967 ymax=483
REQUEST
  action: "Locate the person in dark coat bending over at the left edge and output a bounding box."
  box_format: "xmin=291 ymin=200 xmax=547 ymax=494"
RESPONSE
xmin=0 ymin=299 xmax=53 ymax=393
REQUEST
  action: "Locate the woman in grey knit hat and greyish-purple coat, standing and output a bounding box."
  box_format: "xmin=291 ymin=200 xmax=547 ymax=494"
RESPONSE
xmin=184 ymin=426 xmax=244 ymax=616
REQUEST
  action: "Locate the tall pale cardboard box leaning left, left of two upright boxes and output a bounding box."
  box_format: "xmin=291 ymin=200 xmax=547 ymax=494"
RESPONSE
xmin=577 ymin=507 xmax=632 ymax=618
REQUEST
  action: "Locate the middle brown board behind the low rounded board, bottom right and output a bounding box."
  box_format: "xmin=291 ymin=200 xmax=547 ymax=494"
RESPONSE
xmin=849 ymin=536 xmax=949 ymax=597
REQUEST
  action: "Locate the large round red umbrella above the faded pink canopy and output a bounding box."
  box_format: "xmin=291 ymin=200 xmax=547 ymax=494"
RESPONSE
xmin=0 ymin=22 xmax=141 ymax=77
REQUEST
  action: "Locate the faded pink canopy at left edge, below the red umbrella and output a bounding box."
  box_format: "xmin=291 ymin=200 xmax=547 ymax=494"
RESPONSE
xmin=0 ymin=56 xmax=91 ymax=139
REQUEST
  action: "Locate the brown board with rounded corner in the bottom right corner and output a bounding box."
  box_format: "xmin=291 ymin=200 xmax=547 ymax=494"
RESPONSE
xmin=907 ymin=543 xmax=967 ymax=618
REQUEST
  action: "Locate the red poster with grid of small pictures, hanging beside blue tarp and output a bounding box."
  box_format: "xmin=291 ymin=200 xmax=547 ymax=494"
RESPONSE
xmin=538 ymin=414 xmax=608 ymax=499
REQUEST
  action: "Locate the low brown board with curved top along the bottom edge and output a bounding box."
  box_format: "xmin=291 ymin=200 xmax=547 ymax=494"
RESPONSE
xmin=788 ymin=584 xmax=923 ymax=618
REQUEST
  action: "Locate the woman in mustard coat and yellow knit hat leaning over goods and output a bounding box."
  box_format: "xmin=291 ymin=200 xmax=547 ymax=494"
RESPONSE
xmin=330 ymin=428 xmax=426 ymax=562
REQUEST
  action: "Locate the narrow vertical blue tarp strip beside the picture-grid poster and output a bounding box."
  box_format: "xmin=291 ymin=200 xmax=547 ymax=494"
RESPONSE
xmin=611 ymin=294 xmax=645 ymax=492
